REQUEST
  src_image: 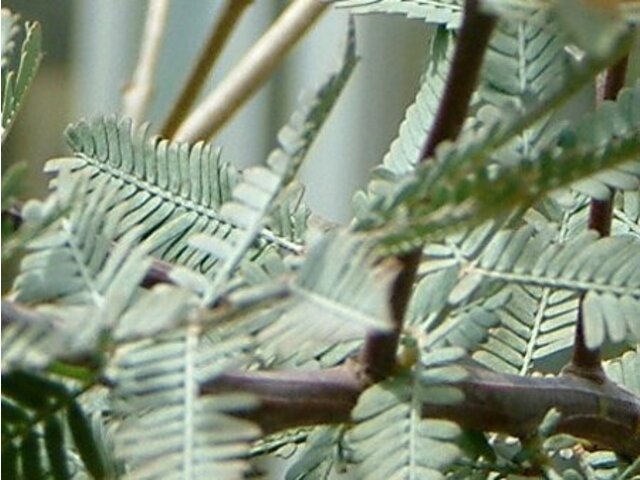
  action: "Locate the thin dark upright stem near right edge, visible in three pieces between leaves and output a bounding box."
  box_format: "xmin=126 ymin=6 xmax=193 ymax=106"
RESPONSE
xmin=565 ymin=55 xmax=629 ymax=381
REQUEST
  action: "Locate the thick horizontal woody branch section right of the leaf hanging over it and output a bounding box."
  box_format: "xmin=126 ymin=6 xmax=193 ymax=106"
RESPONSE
xmin=424 ymin=367 xmax=640 ymax=457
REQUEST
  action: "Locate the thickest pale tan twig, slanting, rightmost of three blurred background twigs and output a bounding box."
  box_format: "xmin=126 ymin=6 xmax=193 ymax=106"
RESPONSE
xmin=175 ymin=0 xmax=327 ymax=142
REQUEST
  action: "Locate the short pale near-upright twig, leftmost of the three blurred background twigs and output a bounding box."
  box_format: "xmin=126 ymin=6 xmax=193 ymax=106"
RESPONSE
xmin=122 ymin=0 xmax=170 ymax=124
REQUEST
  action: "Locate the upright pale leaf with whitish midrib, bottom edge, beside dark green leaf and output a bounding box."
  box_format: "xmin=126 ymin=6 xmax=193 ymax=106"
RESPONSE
xmin=110 ymin=325 xmax=259 ymax=479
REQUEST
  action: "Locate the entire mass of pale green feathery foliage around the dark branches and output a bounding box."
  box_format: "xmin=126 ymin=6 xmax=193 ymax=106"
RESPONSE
xmin=2 ymin=0 xmax=640 ymax=479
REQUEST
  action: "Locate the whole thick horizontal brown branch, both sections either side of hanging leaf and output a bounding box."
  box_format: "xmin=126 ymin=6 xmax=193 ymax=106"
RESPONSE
xmin=202 ymin=362 xmax=640 ymax=456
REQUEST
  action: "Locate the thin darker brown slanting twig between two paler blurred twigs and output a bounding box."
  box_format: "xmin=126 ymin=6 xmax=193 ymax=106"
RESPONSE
xmin=160 ymin=0 xmax=253 ymax=138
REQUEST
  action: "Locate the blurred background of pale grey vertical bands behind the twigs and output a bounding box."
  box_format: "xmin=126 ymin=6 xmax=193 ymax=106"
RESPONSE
xmin=2 ymin=0 xmax=428 ymax=222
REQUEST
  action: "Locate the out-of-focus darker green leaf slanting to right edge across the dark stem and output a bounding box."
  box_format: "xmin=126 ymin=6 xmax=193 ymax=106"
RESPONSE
xmin=378 ymin=79 xmax=640 ymax=248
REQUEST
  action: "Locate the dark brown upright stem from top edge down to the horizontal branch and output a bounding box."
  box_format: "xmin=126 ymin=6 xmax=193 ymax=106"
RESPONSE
xmin=361 ymin=0 xmax=496 ymax=381
